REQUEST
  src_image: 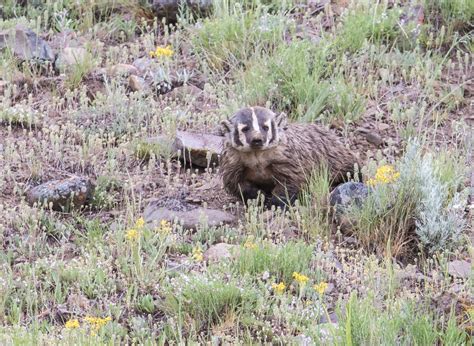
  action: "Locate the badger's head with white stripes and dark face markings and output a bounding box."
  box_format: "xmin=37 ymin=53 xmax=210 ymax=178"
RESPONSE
xmin=221 ymin=107 xmax=286 ymax=152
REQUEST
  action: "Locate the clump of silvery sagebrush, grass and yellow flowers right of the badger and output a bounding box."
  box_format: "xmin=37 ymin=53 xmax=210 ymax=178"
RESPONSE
xmin=350 ymin=143 xmax=466 ymax=256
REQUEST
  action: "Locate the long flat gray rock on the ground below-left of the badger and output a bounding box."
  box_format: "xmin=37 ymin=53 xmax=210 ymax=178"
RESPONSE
xmin=143 ymin=203 xmax=235 ymax=229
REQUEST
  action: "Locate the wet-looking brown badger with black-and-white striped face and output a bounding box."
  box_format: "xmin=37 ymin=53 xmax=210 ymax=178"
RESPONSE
xmin=220 ymin=107 xmax=357 ymax=207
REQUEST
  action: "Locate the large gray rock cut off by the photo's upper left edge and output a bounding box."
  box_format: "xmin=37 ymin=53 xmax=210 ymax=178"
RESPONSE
xmin=0 ymin=25 xmax=55 ymax=62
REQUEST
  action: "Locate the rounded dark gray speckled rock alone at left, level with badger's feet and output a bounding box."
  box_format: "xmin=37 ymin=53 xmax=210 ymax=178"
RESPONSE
xmin=26 ymin=177 xmax=94 ymax=211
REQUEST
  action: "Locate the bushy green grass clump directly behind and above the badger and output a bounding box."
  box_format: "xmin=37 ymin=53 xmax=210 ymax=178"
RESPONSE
xmin=237 ymin=40 xmax=364 ymax=122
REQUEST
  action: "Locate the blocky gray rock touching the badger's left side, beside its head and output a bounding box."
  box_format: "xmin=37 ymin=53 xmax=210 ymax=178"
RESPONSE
xmin=174 ymin=131 xmax=224 ymax=167
